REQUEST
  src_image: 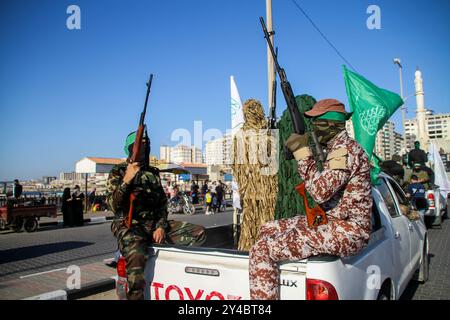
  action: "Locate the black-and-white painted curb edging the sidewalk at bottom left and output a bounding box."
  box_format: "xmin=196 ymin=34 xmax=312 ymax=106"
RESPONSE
xmin=22 ymin=276 xmax=117 ymax=300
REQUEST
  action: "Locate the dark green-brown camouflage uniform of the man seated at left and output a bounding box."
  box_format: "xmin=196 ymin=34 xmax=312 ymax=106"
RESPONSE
xmin=107 ymin=163 xmax=206 ymax=299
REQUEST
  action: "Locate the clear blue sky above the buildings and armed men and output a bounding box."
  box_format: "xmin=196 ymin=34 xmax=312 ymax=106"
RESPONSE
xmin=0 ymin=0 xmax=450 ymax=180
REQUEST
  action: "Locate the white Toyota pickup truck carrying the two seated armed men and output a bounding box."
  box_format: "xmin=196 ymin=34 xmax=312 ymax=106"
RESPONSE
xmin=116 ymin=174 xmax=429 ymax=300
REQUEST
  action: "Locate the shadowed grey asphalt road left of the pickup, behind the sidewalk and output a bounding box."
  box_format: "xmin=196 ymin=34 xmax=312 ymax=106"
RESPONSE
xmin=0 ymin=210 xmax=232 ymax=282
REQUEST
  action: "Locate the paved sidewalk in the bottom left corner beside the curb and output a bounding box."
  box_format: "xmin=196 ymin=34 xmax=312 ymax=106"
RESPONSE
xmin=0 ymin=261 xmax=116 ymax=300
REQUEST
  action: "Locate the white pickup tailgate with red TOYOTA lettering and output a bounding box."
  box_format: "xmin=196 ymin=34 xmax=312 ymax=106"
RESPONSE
xmin=145 ymin=247 xmax=306 ymax=300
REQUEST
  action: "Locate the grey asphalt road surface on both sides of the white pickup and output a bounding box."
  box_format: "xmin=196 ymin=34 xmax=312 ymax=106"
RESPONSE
xmin=0 ymin=210 xmax=450 ymax=300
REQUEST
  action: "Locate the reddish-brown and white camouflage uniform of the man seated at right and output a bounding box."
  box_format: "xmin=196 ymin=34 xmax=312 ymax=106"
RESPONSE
xmin=249 ymin=130 xmax=372 ymax=299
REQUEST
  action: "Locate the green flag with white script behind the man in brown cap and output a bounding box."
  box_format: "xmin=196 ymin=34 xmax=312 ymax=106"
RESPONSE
xmin=343 ymin=66 xmax=403 ymax=183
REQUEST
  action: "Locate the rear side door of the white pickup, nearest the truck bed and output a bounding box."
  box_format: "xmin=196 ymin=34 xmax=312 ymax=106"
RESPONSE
xmin=377 ymin=178 xmax=411 ymax=292
